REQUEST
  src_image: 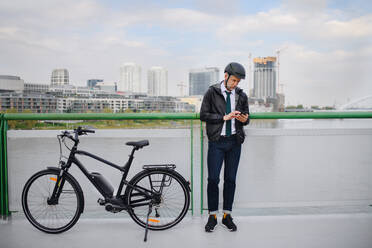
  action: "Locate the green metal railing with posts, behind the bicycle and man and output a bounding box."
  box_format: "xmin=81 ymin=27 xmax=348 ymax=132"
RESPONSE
xmin=0 ymin=112 xmax=372 ymax=216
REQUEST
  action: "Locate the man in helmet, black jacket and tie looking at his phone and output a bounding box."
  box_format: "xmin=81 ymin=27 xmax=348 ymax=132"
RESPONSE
xmin=200 ymin=62 xmax=249 ymax=232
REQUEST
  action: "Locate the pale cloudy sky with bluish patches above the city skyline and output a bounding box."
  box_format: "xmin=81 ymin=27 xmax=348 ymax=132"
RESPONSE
xmin=0 ymin=0 xmax=372 ymax=106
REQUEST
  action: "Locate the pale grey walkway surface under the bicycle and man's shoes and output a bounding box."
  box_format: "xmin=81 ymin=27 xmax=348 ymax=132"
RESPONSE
xmin=0 ymin=213 xmax=372 ymax=248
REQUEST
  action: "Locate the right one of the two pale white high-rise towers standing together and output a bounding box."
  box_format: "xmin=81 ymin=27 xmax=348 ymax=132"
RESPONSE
xmin=147 ymin=66 xmax=168 ymax=96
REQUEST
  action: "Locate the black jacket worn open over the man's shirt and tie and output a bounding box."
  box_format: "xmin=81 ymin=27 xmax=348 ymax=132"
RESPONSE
xmin=200 ymin=81 xmax=250 ymax=144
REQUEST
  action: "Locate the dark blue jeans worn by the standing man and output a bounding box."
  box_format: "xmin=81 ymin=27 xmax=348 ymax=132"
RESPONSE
xmin=207 ymin=135 xmax=241 ymax=211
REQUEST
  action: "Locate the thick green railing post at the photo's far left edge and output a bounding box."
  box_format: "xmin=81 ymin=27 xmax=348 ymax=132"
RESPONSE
xmin=0 ymin=114 xmax=10 ymax=216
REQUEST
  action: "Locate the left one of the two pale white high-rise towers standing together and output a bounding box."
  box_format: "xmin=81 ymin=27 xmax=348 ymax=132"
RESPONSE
xmin=118 ymin=63 xmax=142 ymax=93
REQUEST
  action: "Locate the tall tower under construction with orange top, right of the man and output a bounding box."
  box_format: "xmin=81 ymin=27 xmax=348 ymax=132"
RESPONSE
xmin=253 ymin=57 xmax=276 ymax=99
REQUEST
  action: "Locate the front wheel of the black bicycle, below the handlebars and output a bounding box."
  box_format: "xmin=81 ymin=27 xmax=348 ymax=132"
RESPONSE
xmin=22 ymin=169 xmax=84 ymax=233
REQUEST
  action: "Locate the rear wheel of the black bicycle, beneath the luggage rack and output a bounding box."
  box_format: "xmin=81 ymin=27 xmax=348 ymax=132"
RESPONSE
xmin=126 ymin=170 xmax=190 ymax=230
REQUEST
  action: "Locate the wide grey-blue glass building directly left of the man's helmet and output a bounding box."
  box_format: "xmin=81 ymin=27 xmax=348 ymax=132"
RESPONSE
xmin=189 ymin=67 xmax=220 ymax=96
